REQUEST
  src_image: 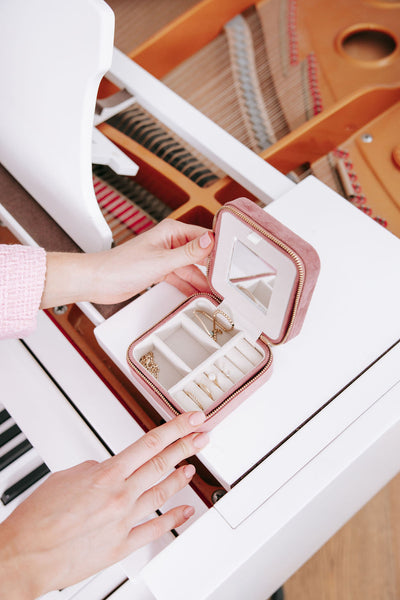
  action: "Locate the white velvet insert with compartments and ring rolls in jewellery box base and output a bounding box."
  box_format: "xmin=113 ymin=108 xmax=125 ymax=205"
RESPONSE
xmin=134 ymin=297 xmax=265 ymax=411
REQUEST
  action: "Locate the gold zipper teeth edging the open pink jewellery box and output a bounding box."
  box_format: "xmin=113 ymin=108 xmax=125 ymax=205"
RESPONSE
xmin=127 ymin=206 xmax=305 ymax=418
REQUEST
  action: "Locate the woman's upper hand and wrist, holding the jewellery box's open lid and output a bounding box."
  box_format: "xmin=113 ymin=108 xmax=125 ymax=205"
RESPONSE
xmin=41 ymin=219 xmax=214 ymax=308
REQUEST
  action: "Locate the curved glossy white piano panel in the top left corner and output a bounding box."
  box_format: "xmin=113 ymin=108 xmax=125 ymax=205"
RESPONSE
xmin=0 ymin=0 xmax=114 ymax=251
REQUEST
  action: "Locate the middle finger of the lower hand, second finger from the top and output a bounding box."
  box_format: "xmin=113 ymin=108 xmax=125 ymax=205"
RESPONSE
xmin=109 ymin=411 xmax=205 ymax=481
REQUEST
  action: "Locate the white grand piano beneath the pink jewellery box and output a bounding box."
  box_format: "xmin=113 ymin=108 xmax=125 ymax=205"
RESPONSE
xmin=0 ymin=0 xmax=400 ymax=600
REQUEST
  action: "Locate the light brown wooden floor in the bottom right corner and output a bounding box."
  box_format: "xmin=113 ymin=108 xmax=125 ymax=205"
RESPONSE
xmin=284 ymin=474 xmax=400 ymax=600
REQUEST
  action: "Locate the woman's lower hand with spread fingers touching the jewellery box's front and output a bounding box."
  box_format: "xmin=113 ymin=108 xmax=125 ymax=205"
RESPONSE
xmin=0 ymin=412 xmax=208 ymax=600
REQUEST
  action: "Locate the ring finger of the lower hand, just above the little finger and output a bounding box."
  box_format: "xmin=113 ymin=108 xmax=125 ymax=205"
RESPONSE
xmin=133 ymin=465 xmax=196 ymax=522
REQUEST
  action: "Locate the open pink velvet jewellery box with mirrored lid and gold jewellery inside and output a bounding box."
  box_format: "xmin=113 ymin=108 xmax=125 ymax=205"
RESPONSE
xmin=127 ymin=198 xmax=320 ymax=430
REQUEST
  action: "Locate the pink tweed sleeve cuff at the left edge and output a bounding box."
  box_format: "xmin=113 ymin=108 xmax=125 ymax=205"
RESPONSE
xmin=0 ymin=244 xmax=46 ymax=339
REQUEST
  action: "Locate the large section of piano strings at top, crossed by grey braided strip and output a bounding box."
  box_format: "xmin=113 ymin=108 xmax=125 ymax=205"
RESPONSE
xmin=159 ymin=0 xmax=322 ymax=152
